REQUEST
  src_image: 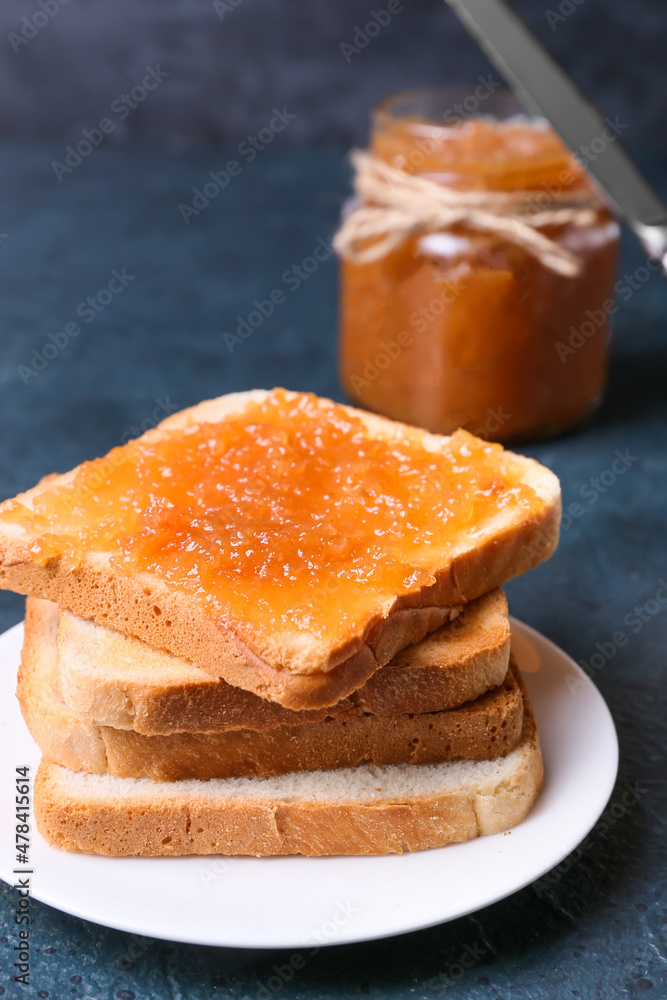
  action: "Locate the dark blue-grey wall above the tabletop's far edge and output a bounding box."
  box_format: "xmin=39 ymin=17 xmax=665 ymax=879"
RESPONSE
xmin=0 ymin=0 xmax=667 ymax=151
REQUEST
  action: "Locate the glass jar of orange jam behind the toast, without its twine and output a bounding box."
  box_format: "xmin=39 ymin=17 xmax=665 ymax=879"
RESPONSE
xmin=340 ymin=90 xmax=619 ymax=441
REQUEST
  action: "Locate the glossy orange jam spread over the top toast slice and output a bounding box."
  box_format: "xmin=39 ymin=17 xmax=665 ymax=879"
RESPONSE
xmin=0 ymin=389 xmax=539 ymax=641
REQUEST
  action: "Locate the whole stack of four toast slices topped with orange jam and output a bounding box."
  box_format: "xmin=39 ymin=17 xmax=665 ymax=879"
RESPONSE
xmin=0 ymin=390 xmax=560 ymax=856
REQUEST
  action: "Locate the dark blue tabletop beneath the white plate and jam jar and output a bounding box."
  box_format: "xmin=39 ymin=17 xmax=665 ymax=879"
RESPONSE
xmin=0 ymin=147 xmax=667 ymax=1000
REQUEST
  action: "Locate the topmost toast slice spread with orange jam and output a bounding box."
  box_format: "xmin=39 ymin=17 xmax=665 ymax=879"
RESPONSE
xmin=0 ymin=390 xmax=560 ymax=710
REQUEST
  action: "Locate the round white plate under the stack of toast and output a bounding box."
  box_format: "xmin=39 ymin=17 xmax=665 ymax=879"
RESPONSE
xmin=0 ymin=621 xmax=618 ymax=949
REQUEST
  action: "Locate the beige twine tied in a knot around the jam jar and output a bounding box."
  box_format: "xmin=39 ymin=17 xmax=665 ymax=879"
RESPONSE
xmin=333 ymin=149 xmax=603 ymax=277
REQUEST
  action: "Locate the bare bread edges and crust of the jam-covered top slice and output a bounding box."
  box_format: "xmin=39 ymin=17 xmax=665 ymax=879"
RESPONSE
xmin=0 ymin=393 xmax=560 ymax=710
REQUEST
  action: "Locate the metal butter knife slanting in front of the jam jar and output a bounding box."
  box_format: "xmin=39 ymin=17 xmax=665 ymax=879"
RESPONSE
xmin=447 ymin=0 xmax=667 ymax=274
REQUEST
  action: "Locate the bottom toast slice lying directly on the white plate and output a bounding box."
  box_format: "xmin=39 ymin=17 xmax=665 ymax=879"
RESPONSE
xmin=34 ymin=694 xmax=543 ymax=857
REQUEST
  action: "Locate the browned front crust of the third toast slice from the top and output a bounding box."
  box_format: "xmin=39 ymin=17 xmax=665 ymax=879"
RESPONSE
xmin=95 ymin=671 xmax=523 ymax=781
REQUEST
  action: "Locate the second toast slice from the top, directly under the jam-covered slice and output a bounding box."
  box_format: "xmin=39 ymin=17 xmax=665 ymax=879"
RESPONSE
xmin=39 ymin=588 xmax=510 ymax=736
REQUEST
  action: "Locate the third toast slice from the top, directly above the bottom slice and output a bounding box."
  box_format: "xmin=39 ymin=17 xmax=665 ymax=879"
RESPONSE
xmin=17 ymin=600 xmax=523 ymax=781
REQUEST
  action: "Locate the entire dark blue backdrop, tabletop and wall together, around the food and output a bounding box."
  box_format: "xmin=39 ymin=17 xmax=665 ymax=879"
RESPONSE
xmin=0 ymin=0 xmax=667 ymax=1000
